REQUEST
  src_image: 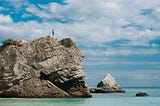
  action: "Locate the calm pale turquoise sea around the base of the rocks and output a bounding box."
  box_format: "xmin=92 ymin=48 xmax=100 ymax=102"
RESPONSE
xmin=0 ymin=88 xmax=160 ymax=106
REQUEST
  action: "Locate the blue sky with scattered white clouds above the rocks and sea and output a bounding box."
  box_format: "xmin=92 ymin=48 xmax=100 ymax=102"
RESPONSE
xmin=0 ymin=0 xmax=160 ymax=87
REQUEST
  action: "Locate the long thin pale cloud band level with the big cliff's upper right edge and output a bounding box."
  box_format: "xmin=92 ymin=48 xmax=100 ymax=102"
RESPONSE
xmin=82 ymin=47 xmax=160 ymax=56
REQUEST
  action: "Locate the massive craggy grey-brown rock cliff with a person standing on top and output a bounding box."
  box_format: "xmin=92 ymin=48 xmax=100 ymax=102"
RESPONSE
xmin=0 ymin=36 xmax=91 ymax=97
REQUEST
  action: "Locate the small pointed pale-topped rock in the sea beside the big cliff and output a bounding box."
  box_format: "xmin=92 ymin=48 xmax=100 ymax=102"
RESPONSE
xmin=90 ymin=73 xmax=125 ymax=93
